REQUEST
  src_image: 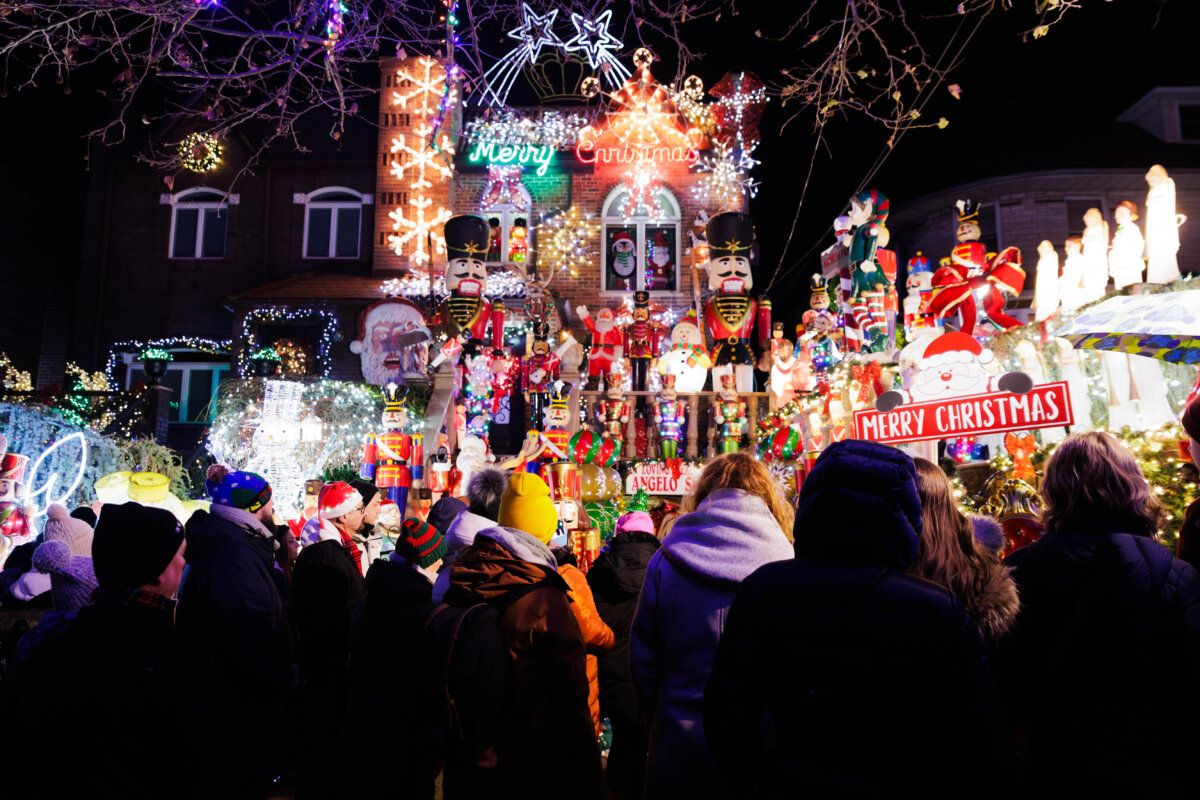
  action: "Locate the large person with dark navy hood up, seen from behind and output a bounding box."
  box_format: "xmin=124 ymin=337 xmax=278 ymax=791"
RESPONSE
xmin=704 ymin=440 xmax=1008 ymax=798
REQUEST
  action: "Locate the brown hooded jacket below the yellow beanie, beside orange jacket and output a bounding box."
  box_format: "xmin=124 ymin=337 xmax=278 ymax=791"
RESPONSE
xmin=445 ymin=528 xmax=602 ymax=800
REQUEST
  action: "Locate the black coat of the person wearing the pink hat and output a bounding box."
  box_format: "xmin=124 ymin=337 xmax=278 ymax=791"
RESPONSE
xmin=588 ymin=534 xmax=659 ymax=722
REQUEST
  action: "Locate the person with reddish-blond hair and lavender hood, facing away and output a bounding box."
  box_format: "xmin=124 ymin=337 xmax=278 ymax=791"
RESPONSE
xmin=629 ymin=453 xmax=792 ymax=799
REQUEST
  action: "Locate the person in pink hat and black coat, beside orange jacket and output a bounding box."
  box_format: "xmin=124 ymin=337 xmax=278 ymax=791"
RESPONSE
xmin=588 ymin=511 xmax=659 ymax=800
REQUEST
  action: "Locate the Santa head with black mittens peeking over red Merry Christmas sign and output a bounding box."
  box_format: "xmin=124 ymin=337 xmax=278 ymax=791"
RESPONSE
xmin=875 ymin=331 xmax=1033 ymax=413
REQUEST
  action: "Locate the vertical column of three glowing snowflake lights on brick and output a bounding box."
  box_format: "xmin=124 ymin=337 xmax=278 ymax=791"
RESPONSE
xmin=388 ymin=58 xmax=454 ymax=265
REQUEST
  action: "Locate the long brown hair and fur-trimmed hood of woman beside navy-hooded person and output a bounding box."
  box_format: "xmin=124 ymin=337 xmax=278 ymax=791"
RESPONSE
xmin=908 ymin=458 xmax=1020 ymax=644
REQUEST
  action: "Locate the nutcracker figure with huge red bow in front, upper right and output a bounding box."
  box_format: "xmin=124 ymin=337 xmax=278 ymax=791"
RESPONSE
xmin=929 ymin=200 xmax=1025 ymax=335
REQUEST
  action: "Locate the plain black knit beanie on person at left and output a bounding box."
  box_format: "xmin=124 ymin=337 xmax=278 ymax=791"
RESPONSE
xmin=91 ymin=500 xmax=184 ymax=589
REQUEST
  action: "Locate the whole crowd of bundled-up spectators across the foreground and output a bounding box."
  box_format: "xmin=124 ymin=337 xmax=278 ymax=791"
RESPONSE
xmin=0 ymin=401 xmax=1200 ymax=800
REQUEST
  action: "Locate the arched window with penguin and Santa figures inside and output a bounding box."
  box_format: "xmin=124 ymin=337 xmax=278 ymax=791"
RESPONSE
xmin=601 ymin=186 xmax=680 ymax=291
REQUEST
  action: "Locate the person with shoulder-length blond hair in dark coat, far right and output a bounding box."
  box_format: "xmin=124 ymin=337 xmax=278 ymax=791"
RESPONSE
xmin=997 ymin=431 xmax=1200 ymax=796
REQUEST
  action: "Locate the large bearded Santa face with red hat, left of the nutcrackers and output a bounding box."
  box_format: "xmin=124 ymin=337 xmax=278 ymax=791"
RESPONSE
xmin=350 ymin=297 xmax=432 ymax=386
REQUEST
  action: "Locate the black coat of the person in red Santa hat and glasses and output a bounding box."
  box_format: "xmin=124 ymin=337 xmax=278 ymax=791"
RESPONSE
xmin=292 ymin=540 xmax=362 ymax=691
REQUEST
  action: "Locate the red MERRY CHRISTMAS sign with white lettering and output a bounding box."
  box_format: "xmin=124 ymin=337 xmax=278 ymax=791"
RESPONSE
xmin=854 ymin=381 xmax=1075 ymax=444
